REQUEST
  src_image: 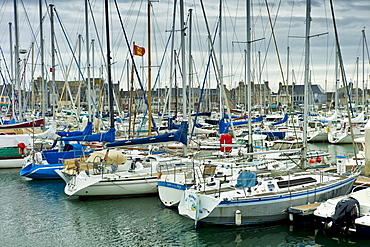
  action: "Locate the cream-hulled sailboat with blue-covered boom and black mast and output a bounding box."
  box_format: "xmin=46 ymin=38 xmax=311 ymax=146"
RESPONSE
xmin=64 ymin=0 xmax=188 ymax=197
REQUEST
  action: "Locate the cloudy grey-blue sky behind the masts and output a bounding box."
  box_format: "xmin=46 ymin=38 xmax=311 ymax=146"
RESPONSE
xmin=0 ymin=0 xmax=370 ymax=92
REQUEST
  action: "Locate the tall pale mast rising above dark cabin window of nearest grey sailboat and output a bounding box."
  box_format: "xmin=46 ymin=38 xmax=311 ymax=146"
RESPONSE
xmin=303 ymin=0 xmax=311 ymax=168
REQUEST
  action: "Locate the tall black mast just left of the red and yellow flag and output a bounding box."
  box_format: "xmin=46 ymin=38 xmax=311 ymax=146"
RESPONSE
xmin=104 ymin=0 xmax=114 ymax=128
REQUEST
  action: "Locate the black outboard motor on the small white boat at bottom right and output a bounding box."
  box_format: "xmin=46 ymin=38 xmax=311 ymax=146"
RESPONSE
xmin=328 ymin=197 xmax=360 ymax=236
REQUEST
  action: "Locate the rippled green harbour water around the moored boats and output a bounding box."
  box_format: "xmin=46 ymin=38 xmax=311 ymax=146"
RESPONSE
xmin=0 ymin=144 xmax=370 ymax=247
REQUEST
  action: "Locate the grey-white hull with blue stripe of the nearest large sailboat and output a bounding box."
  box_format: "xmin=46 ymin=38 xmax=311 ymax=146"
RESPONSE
xmin=179 ymin=174 xmax=355 ymax=225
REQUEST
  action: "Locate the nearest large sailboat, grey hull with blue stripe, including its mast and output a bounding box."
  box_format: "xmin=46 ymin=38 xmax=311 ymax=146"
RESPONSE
xmin=178 ymin=0 xmax=358 ymax=226
